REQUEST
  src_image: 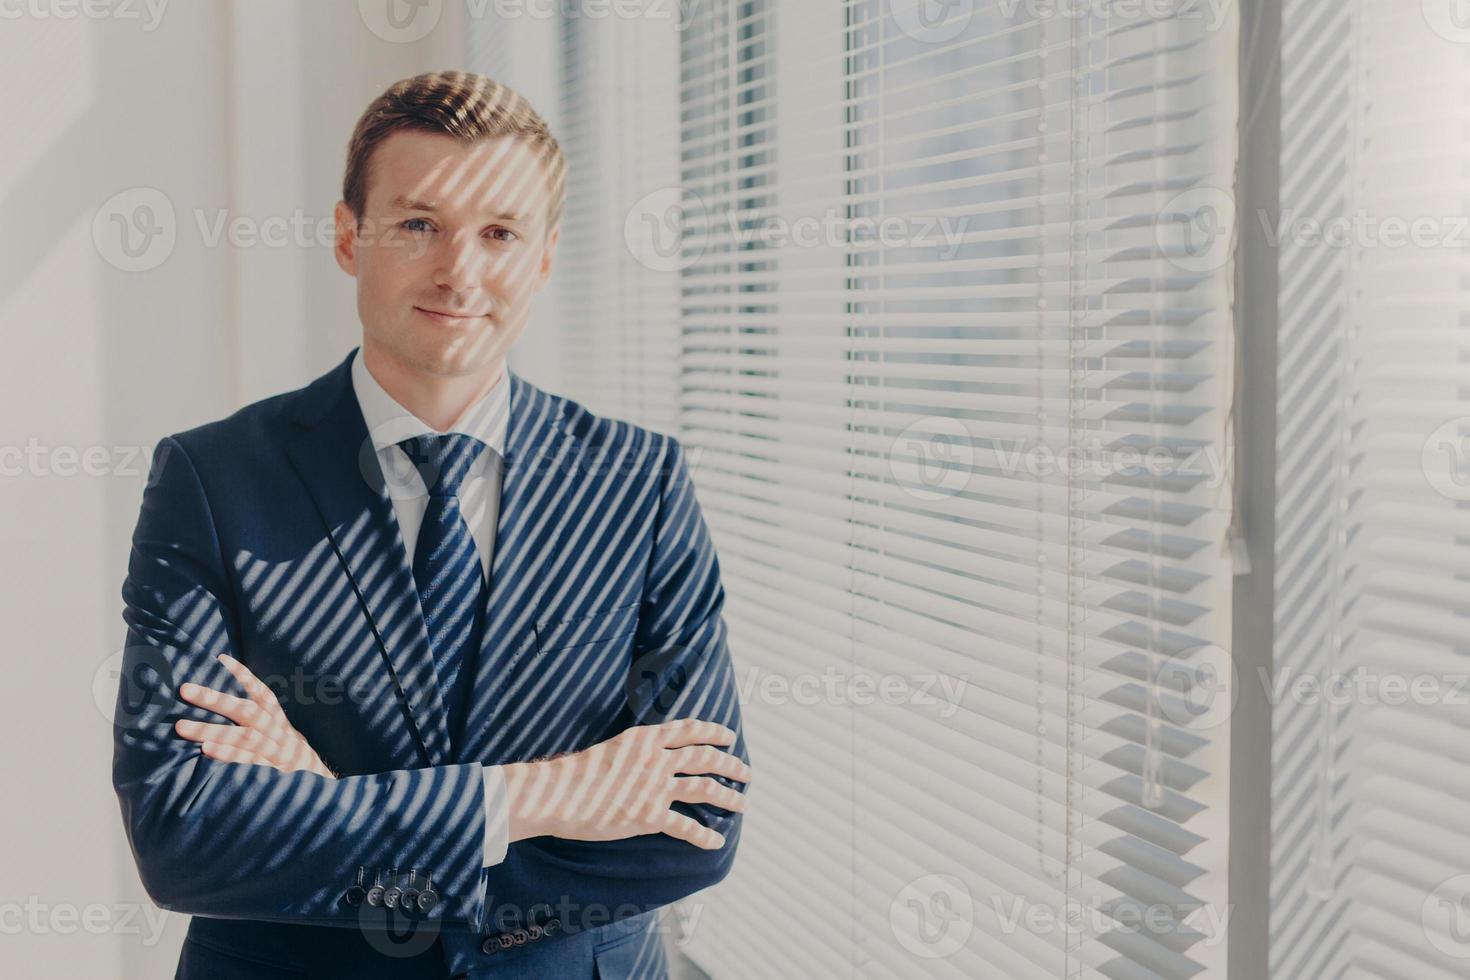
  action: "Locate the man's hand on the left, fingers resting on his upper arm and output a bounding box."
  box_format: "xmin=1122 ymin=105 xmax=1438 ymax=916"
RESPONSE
xmin=173 ymin=654 xmax=337 ymax=779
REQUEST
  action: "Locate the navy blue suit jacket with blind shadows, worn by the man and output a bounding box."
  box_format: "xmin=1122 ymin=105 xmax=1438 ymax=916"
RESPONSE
xmin=113 ymin=351 xmax=748 ymax=977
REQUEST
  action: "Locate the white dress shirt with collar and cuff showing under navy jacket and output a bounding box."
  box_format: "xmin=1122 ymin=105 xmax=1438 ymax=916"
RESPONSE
xmin=353 ymin=350 xmax=510 ymax=867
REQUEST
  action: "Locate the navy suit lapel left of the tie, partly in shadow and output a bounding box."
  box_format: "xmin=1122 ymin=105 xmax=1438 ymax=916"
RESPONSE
xmin=287 ymin=350 xmax=450 ymax=765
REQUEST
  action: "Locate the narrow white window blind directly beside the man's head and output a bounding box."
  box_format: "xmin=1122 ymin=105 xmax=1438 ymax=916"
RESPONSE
xmin=538 ymin=4 xmax=679 ymax=432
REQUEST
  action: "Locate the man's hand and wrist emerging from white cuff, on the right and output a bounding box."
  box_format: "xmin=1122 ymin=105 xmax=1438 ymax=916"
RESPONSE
xmin=506 ymin=718 xmax=750 ymax=851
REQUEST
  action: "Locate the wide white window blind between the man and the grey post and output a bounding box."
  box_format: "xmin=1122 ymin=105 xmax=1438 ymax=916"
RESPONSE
xmin=476 ymin=0 xmax=1236 ymax=979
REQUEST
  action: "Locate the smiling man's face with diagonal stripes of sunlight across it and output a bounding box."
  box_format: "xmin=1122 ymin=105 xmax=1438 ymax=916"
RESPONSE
xmin=337 ymin=131 xmax=559 ymax=378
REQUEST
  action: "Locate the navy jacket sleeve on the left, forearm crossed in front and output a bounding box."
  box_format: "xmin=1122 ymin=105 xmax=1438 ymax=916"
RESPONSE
xmin=112 ymin=436 xmax=485 ymax=930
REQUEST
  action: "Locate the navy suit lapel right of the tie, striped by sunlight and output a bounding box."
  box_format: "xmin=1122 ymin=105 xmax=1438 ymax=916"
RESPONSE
xmin=456 ymin=373 xmax=581 ymax=764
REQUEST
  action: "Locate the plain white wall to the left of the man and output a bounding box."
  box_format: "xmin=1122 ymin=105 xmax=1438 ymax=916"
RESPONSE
xmin=0 ymin=0 xmax=476 ymax=979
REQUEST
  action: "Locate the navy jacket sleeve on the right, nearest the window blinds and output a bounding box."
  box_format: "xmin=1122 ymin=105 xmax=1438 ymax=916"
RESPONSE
xmin=473 ymin=438 xmax=750 ymax=930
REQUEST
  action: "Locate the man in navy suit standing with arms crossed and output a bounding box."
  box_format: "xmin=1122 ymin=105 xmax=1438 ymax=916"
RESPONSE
xmin=113 ymin=72 xmax=750 ymax=979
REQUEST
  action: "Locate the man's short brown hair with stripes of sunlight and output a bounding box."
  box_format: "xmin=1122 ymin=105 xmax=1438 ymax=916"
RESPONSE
xmin=343 ymin=72 xmax=566 ymax=228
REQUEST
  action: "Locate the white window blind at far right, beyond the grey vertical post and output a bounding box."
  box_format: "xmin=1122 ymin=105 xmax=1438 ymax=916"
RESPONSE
xmin=1270 ymin=0 xmax=1470 ymax=980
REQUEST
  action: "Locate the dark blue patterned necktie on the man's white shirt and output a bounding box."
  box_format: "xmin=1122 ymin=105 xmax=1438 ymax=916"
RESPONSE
xmin=398 ymin=432 xmax=487 ymax=746
